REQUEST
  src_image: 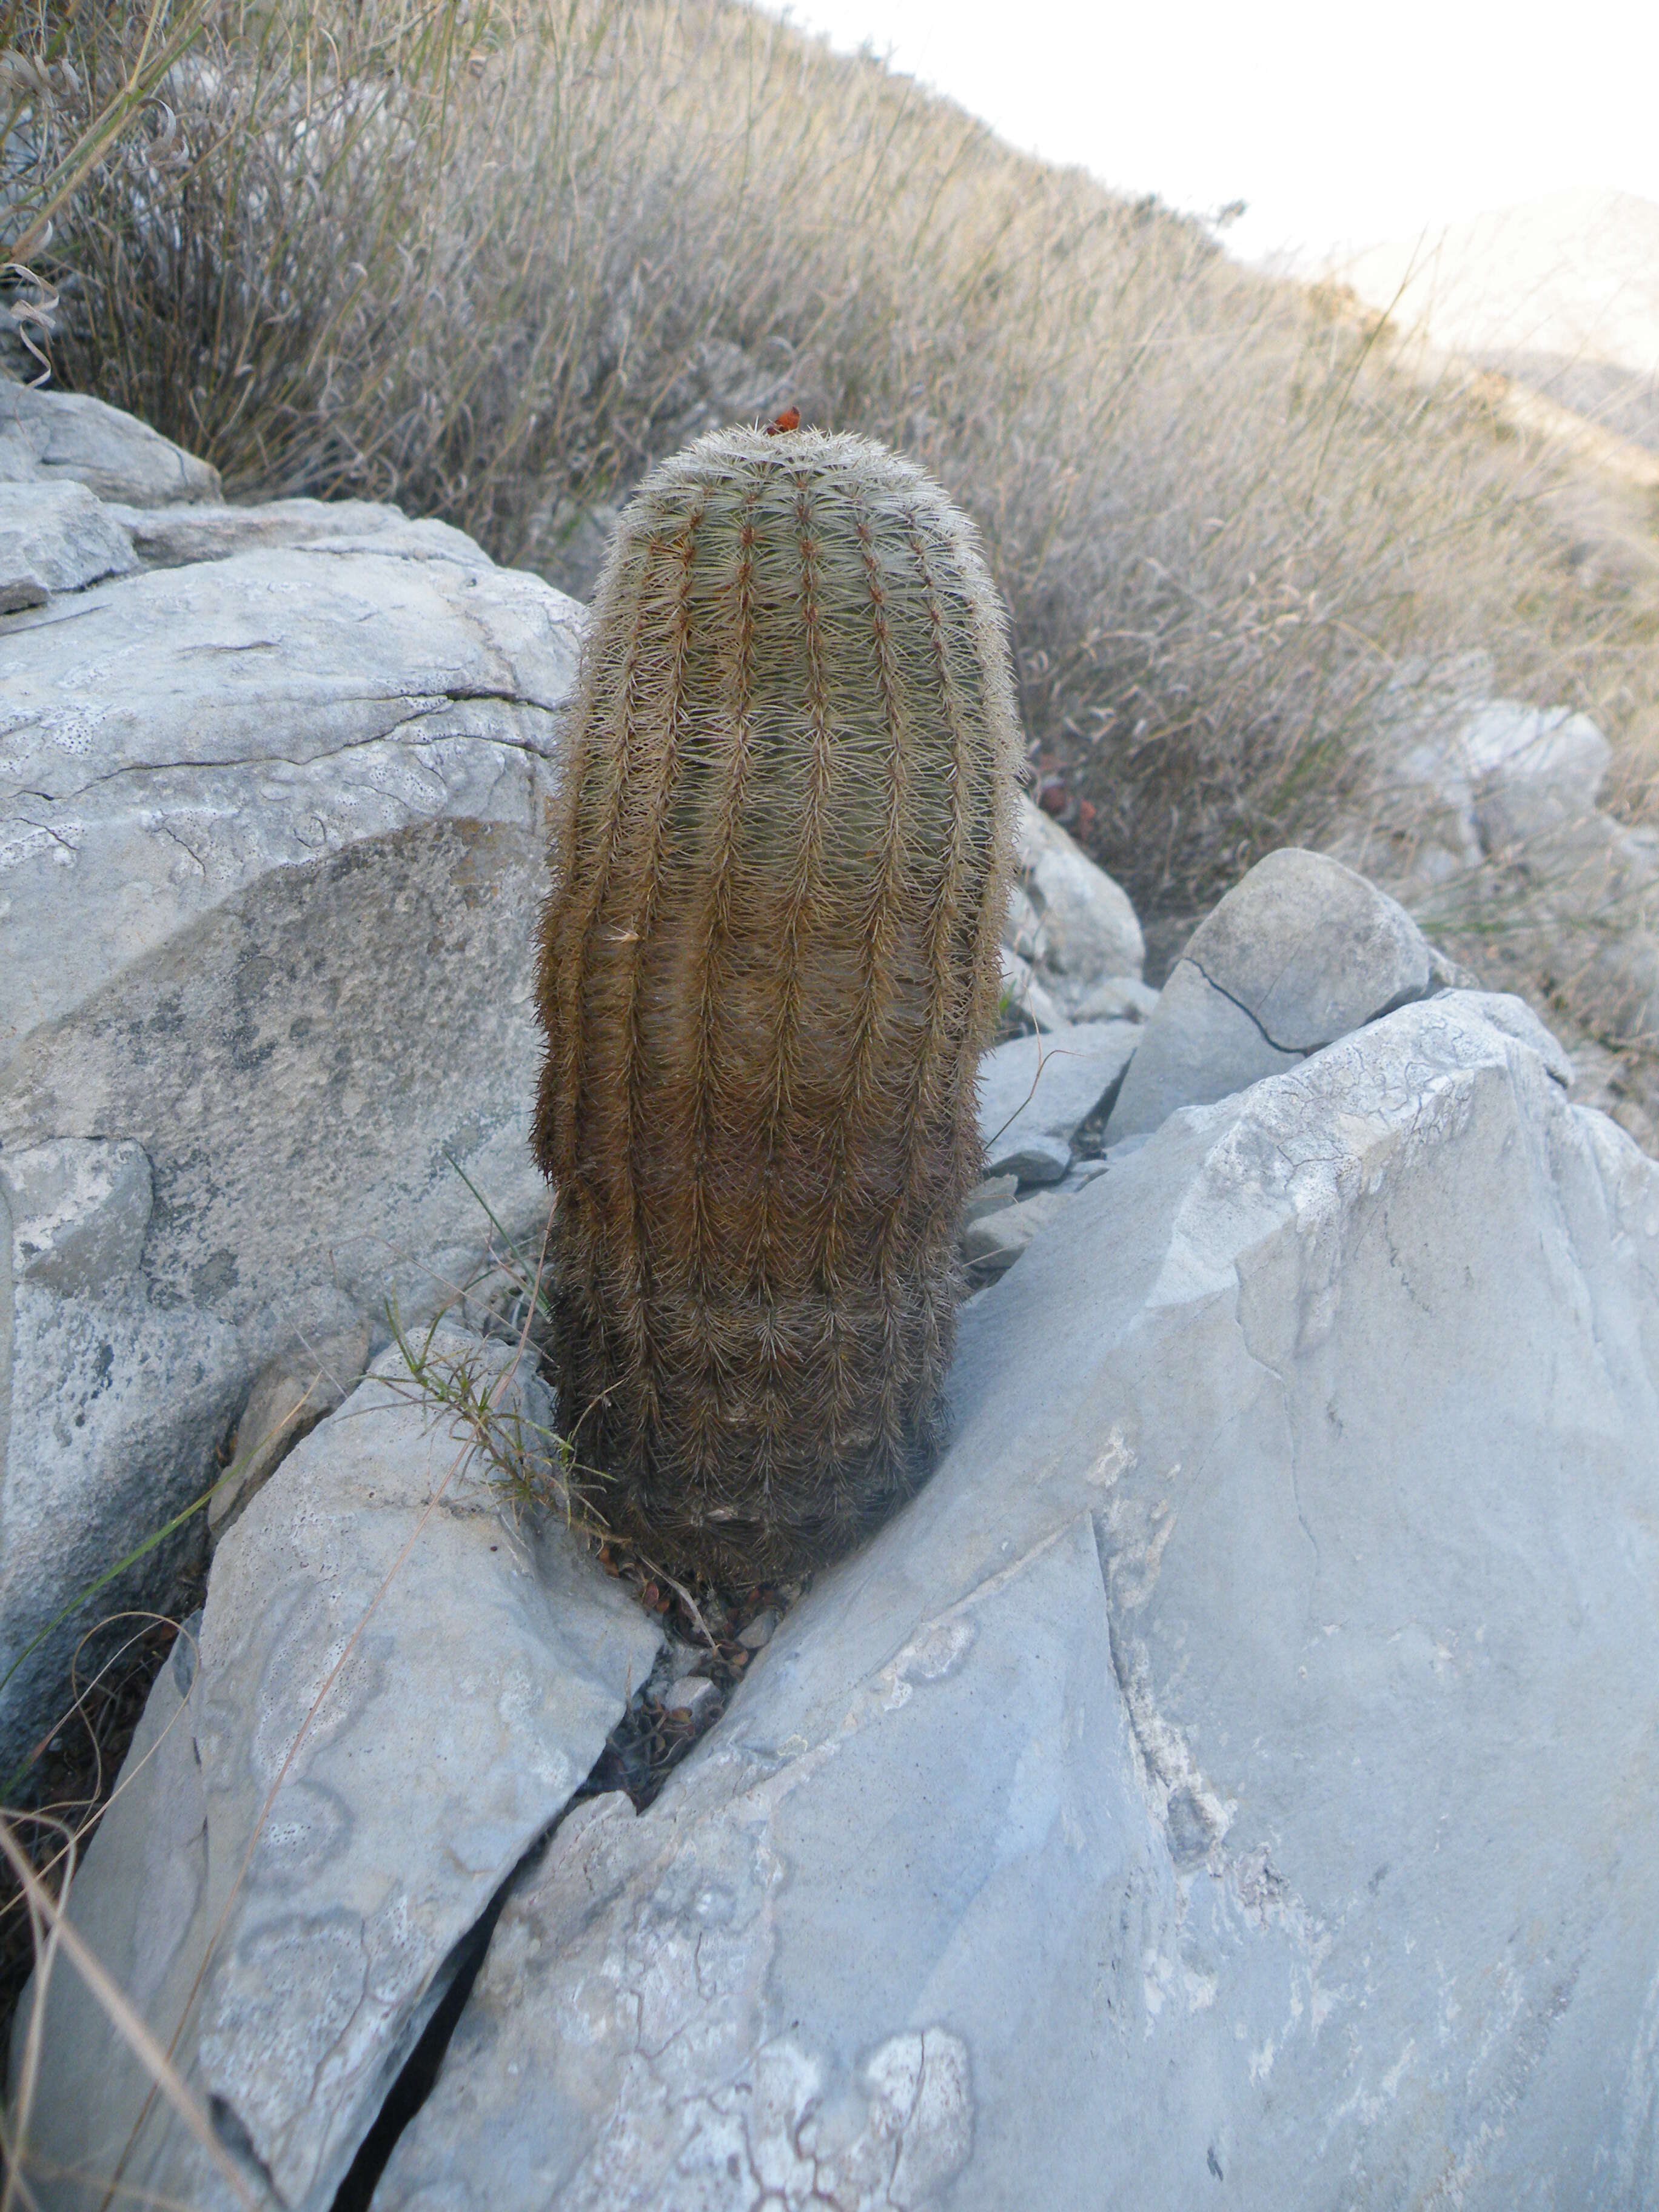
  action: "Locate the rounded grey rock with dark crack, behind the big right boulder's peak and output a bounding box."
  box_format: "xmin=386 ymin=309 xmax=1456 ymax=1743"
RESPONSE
xmin=1106 ymin=845 xmax=1436 ymax=1144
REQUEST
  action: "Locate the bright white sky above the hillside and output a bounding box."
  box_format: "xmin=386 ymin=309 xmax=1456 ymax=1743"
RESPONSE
xmin=770 ymin=0 xmax=1659 ymax=259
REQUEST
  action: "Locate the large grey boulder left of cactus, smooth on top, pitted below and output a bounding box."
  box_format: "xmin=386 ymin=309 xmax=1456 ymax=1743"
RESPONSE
xmin=0 ymin=453 xmax=580 ymax=1772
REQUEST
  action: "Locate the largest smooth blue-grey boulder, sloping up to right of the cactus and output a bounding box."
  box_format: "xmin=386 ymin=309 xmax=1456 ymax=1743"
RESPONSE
xmin=374 ymin=993 xmax=1659 ymax=2212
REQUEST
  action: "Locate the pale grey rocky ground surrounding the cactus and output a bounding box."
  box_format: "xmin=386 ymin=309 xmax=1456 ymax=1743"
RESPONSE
xmin=0 ymin=389 xmax=1659 ymax=2212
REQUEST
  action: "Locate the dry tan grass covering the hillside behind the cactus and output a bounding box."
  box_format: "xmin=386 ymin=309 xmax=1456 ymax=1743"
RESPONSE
xmin=11 ymin=0 xmax=1655 ymax=916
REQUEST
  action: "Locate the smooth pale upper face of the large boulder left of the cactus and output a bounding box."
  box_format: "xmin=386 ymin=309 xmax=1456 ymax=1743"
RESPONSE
xmin=0 ymin=549 xmax=577 ymax=1057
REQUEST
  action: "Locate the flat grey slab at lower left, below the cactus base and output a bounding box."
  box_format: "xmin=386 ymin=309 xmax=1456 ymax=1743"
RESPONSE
xmin=15 ymin=1329 xmax=662 ymax=2212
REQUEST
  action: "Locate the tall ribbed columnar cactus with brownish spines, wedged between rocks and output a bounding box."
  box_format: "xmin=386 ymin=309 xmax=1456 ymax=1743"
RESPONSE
xmin=535 ymin=429 xmax=1017 ymax=1581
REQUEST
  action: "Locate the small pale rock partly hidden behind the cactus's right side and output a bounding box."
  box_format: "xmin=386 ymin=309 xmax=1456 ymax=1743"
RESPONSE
xmin=1002 ymin=792 xmax=1146 ymax=1027
